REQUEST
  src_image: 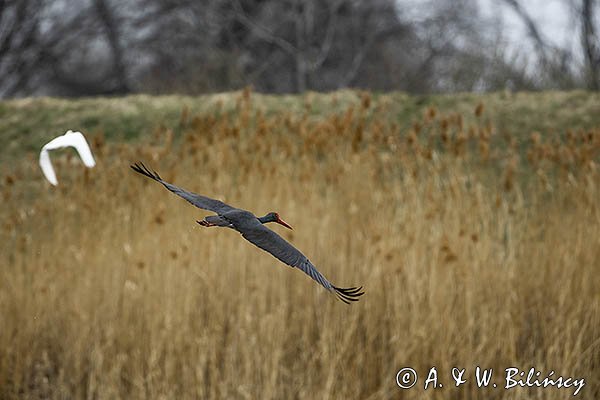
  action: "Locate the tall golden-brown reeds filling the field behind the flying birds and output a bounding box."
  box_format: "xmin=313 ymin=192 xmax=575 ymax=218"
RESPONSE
xmin=0 ymin=91 xmax=600 ymax=399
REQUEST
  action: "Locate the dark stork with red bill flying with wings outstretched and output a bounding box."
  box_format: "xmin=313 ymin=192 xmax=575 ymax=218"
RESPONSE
xmin=131 ymin=163 xmax=364 ymax=304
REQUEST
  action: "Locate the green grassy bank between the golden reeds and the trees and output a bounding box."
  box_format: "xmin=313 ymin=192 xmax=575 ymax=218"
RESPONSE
xmin=0 ymin=91 xmax=600 ymax=161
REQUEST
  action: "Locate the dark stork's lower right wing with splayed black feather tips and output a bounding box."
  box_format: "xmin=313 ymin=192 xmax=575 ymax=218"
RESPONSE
xmin=234 ymin=220 xmax=364 ymax=303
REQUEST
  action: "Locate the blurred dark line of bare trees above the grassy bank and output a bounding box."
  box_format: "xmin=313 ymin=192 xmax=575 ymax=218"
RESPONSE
xmin=0 ymin=0 xmax=600 ymax=98
